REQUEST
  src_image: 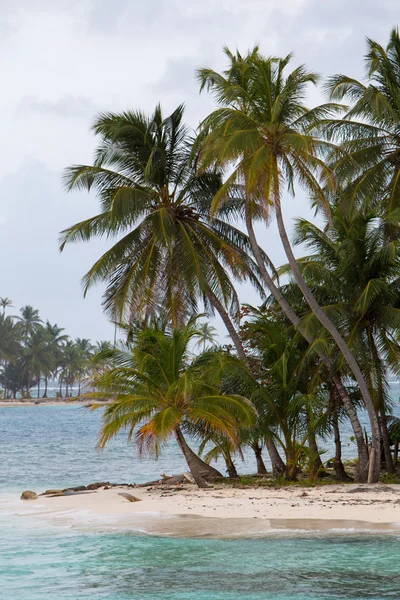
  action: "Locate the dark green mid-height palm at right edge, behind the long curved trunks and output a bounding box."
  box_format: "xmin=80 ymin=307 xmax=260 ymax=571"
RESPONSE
xmin=290 ymin=200 xmax=400 ymax=472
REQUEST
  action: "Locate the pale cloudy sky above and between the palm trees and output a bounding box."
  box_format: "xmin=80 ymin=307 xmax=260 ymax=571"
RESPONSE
xmin=0 ymin=0 xmax=398 ymax=339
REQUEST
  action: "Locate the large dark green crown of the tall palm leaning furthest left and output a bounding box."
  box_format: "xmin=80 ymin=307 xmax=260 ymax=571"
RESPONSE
xmin=60 ymin=106 xmax=262 ymax=359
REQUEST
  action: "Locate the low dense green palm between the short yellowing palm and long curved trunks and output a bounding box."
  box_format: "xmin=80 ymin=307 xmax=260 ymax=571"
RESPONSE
xmin=246 ymin=309 xmax=328 ymax=479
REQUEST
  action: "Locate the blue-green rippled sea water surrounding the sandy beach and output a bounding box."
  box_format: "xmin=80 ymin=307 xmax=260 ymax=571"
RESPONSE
xmin=0 ymin=406 xmax=400 ymax=600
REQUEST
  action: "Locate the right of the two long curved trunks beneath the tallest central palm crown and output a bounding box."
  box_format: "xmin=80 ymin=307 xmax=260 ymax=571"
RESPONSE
xmin=275 ymin=197 xmax=380 ymax=483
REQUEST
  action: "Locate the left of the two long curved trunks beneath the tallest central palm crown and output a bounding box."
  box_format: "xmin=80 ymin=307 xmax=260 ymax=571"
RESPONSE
xmin=245 ymin=202 xmax=369 ymax=482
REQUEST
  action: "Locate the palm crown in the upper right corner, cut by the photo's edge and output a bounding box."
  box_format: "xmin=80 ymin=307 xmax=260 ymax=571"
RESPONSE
xmin=325 ymin=27 xmax=400 ymax=227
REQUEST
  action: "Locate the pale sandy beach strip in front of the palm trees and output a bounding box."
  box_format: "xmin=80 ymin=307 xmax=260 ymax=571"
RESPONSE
xmin=24 ymin=484 xmax=400 ymax=536
